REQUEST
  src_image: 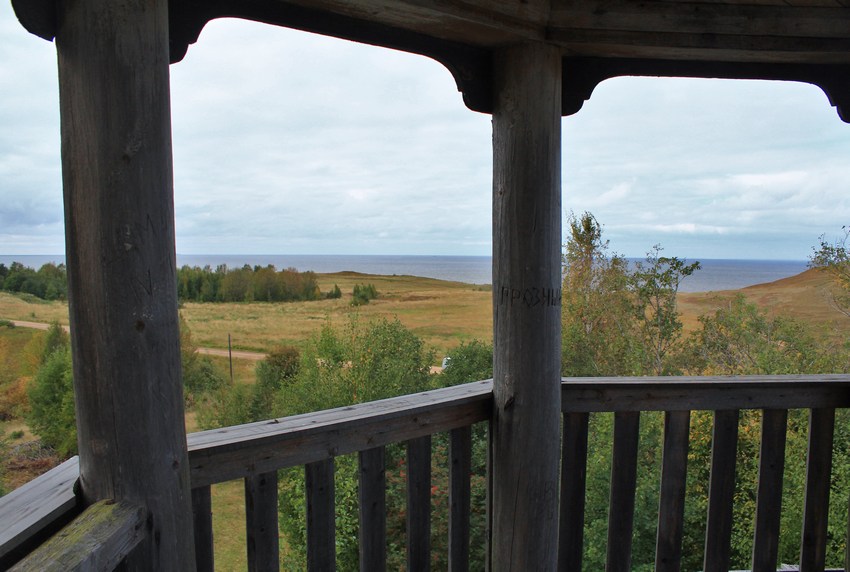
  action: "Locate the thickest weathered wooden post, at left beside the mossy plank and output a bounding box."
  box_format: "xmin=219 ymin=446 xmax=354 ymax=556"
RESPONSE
xmin=56 ymin=0 xmax=195 ymax=570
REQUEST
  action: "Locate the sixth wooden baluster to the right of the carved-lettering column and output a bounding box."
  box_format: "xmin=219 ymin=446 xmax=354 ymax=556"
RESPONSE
xmin=800 ymin=408 xmax=835 ymax=572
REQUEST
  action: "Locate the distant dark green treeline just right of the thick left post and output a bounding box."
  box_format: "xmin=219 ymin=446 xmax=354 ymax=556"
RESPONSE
xmin=177 ymin=264 xmax=322 ymax=302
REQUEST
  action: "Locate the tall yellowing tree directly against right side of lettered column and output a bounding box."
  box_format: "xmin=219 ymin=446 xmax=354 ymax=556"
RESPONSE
xmin=561 ymin=212 xmax=635 ymax=376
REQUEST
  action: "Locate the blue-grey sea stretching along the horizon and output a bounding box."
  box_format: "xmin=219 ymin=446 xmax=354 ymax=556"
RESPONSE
xmin=0 ymin=254 xmax=807 ymax=292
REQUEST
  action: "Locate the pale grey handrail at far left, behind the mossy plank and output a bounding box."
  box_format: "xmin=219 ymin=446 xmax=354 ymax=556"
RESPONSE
xmin=0 ymin=457 xmax=80 ymax=569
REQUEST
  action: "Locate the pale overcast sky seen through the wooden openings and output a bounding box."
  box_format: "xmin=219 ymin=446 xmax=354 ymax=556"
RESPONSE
xmin=0 ymin=5 xmax=850 ymax=260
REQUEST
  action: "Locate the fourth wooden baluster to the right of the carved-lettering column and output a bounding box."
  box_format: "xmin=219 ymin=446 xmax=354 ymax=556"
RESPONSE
xmin=703 ymin=410 xmax=738 ymax=572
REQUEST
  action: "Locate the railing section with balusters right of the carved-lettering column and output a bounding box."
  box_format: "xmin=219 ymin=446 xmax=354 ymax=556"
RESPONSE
xmin=559 ymin=375 xmax=850 ymax=572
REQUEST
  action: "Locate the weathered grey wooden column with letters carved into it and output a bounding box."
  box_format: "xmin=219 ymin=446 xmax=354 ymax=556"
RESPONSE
xmin=490 ymin=44 xmax=562 ymax=572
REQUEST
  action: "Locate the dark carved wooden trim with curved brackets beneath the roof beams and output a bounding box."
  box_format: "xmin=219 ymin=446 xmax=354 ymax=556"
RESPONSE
xmin=12 ymin=0 xmax=850 ymax=123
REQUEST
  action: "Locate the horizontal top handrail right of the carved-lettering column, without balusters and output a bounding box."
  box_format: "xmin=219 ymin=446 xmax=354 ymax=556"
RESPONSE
xmin=561 ymin=375 xmax=850 ymax=413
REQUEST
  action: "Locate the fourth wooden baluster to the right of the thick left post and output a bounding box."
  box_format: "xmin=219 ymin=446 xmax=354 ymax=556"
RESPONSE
xmin=358 ymin=447 xmax=387 ymax=572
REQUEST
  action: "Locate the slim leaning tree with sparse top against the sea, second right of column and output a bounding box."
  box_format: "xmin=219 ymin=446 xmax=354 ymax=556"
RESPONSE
xmin=629 ymin=244 xmax=700 ymax=375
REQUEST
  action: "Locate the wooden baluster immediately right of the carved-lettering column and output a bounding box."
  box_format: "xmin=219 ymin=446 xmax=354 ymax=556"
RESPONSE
xmin=558 ymin=413 xmax=590 ymax=572
